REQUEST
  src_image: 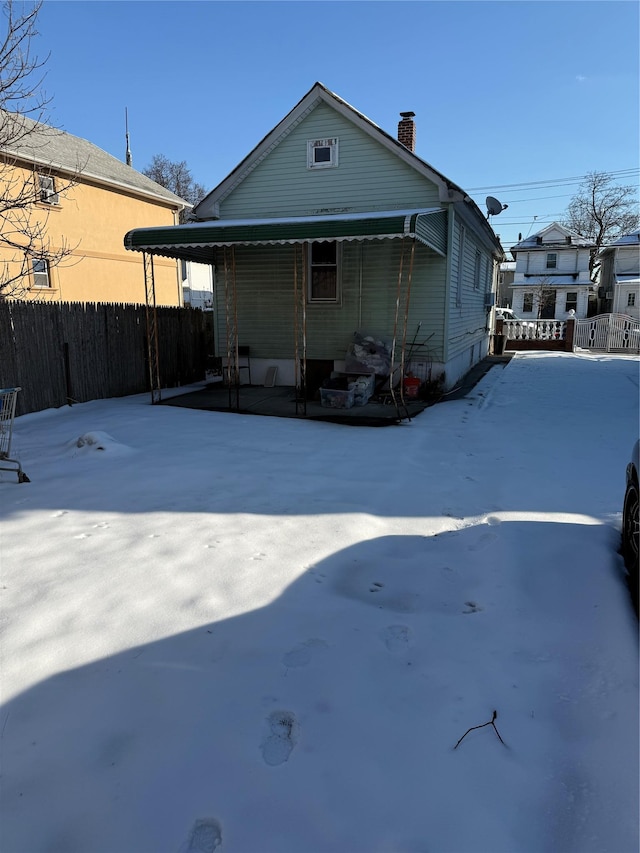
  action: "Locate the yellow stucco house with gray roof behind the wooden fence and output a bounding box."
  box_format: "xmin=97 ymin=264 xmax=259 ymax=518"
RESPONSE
xmin=0 ymin=113 xmax=190 ymax=306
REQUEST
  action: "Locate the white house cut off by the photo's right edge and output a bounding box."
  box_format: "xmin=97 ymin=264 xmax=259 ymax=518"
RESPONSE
xmin=598 ymin=230 xmax=640 ymax=320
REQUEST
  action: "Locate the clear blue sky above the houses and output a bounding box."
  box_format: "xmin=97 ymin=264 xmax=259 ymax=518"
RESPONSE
xmin=34 ymin=0 xmax=640 ymax=249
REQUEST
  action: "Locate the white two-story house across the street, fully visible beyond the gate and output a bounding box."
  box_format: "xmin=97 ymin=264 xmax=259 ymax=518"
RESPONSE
xmin=511 ymin=222 xmax=595 ymax=320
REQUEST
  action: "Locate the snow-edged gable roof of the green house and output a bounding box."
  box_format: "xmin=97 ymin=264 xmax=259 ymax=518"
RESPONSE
xmin=192 ymin=83 xmax=498 ymax=243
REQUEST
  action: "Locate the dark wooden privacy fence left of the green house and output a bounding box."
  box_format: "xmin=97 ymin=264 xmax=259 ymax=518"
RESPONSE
xmin=0 ymin=301 xmax=212 ymax=415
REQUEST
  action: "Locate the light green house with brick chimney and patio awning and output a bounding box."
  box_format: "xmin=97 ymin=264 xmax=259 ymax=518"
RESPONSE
xmin=125 ymin=83 xmax=503 ymax=393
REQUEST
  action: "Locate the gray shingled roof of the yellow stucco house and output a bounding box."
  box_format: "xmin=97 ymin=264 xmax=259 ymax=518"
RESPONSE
xmin=0 ymin=111 xmax=191 ymax=208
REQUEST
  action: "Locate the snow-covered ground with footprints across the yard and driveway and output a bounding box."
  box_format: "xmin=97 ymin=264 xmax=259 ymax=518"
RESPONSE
xmin=0 ymin=353 xmax=639 ymax=853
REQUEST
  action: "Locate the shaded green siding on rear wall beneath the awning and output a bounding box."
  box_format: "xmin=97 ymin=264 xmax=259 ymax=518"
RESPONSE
xmin=216 ymin=240 xmax=446 ymax=360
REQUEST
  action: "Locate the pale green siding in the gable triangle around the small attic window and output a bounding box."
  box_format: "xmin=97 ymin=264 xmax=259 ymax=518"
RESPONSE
xmin=220 ymin=103 xmax=439 ymax=219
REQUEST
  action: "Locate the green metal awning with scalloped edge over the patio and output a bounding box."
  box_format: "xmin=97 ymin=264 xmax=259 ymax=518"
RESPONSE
xmin=124 ymin=207 xmax=447 ymax=263
